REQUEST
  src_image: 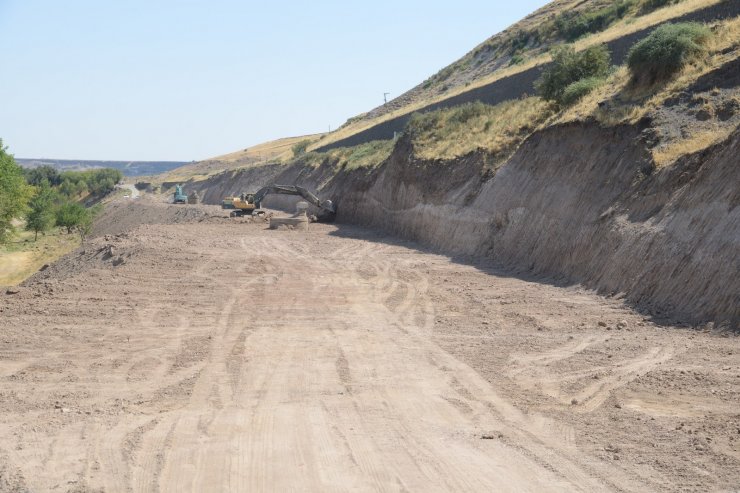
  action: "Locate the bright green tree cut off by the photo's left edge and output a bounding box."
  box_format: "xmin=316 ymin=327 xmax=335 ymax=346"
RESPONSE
xmin=0 ymin=139 xmax=33 ymax=243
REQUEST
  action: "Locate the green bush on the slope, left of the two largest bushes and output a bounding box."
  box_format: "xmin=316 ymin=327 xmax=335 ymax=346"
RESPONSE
xmin=535 ymin=45 xmax=611 ymax=104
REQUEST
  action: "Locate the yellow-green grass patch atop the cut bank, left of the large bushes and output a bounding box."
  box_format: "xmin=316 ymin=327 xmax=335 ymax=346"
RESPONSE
xmin=406 ymin=97 xmax=553 ymax=159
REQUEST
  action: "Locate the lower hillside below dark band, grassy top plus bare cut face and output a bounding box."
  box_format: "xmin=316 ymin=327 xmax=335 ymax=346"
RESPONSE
xmin=181 ymin=3 xmax=740 ymax=327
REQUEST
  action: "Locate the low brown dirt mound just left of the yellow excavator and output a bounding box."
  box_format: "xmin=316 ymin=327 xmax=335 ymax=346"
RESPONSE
xmin=92 ymin=198 xmax=228 ymax=236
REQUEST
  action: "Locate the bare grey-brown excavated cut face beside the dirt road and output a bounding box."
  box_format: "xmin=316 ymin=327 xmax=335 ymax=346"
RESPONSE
xmin=192 ymin=123 xmax=740 ymax=328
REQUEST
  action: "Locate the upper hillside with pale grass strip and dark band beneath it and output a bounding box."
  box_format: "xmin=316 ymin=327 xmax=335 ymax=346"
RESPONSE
xmin=312 ymin=0 xmax=740 ymax=150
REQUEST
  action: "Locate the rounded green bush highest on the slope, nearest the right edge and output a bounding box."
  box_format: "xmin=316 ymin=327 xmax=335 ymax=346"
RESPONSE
xmin=627 ymin=22 xmax=712 ymax=84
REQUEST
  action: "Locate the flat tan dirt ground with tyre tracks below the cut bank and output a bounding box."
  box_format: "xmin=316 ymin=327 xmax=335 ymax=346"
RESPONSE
xmin=0 ymin=199 xmax=740 ymax=492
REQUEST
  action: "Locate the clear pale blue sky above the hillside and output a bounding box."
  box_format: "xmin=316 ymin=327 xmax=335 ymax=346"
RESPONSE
xmin=0 ymin=0 xmax=546 ymax=161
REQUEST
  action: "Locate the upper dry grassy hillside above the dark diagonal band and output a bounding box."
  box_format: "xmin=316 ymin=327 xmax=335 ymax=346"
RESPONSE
xmin=313 ymin=0 xmax=721 ymax=152
